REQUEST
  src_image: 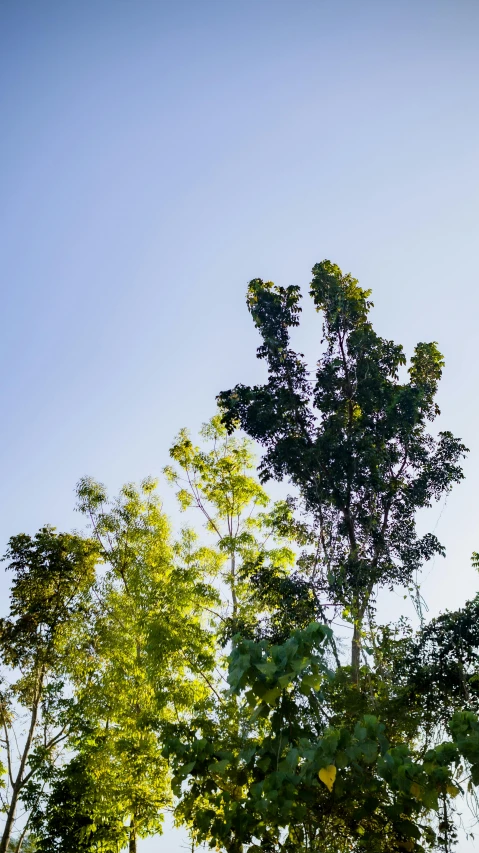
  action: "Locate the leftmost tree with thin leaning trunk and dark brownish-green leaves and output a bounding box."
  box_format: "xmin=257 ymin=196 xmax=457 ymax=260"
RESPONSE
xmin=0 ymin=527 xmax=98 ymax=853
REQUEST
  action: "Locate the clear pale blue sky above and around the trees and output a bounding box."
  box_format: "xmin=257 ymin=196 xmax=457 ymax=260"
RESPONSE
xmin=0 ymin=0 xmax=479 ymax=853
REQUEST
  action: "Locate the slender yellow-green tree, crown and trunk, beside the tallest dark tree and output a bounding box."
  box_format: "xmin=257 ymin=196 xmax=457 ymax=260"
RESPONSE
xmin=165 ymin=415 xmax=302 ymax=838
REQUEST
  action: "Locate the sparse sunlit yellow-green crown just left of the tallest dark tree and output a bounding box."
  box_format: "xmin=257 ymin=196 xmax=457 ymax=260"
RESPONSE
xmin=164 ymin=415 xmax=295 ymax=640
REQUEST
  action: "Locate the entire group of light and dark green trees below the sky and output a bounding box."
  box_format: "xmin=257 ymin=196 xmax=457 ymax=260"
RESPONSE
xmin=0 ymin=261 xmax=479 ymax=853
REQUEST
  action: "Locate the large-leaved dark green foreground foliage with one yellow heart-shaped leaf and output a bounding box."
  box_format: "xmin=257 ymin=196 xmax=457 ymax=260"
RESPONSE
xmin=167 ymin=624 xmax=479 ymax=853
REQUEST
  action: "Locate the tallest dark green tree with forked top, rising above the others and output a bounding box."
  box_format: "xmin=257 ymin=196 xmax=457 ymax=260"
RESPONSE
xmin=218 ymin=261 xmax=466 ymax=681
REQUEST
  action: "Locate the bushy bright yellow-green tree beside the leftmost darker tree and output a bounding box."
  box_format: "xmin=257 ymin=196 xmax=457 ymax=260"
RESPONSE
xmin=29 ymin=479 xmax=216 ymax=853
